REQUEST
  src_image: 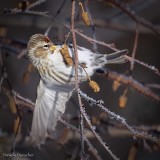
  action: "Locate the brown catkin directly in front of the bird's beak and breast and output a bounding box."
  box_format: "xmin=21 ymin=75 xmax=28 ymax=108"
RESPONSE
xmin=60 ymin=44 xmax=73 ymax=66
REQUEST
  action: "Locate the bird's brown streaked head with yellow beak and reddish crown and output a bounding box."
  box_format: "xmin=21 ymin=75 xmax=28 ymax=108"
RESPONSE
xmin=27 ymin=34 xmax=56 ymax=58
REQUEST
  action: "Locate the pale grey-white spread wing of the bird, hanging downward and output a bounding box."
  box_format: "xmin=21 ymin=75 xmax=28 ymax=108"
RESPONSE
xmin=29 ymin=80 xmax=70 ymax=146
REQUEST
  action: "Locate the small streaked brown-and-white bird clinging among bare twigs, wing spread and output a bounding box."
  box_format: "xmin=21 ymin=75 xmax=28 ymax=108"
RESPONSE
xmin=27 ymin=34 xmax=128 ymax=146
